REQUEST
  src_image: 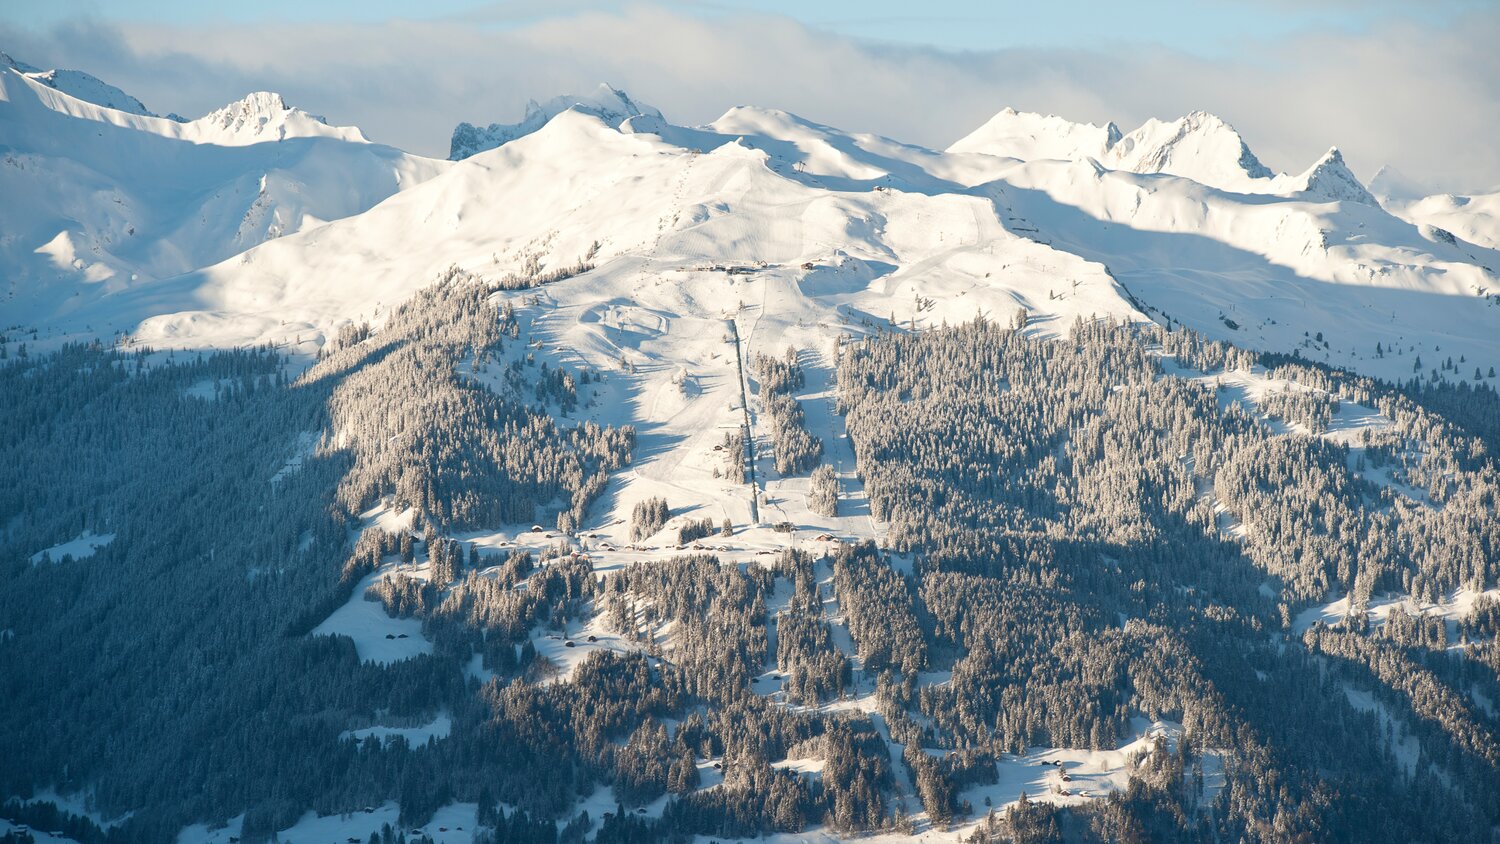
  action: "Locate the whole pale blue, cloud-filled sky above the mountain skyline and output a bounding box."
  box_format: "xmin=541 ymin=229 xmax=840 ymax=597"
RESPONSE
xmin=0 ymin=0 xmax=1500 ymax=192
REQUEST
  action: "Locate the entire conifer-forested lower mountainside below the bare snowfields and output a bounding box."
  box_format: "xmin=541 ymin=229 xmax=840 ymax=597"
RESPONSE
xmin=0 ymin=278 xmax=1500 ymax=843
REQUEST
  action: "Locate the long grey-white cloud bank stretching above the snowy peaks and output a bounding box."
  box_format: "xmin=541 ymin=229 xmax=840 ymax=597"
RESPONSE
xmin=0 ymin=3 xmax=1500 ymax=190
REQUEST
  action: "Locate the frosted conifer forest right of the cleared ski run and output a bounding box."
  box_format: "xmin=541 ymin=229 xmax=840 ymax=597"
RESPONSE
xmin=840 ymin=321 xmax=1500 ymax=841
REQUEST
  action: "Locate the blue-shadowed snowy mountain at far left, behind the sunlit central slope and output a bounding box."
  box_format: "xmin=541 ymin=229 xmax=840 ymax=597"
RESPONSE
xmin=0 ymin=57 xmax=449 ymax=322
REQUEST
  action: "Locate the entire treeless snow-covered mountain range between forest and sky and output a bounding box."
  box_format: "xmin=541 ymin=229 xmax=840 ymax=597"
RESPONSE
xmin=0 ymin=60 xmax=1500 ymax=389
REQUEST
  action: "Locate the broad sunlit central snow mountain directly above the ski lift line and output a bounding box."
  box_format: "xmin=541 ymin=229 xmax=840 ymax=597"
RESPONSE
xmin=108 ymin=105 xmax=1134 ymax=360
